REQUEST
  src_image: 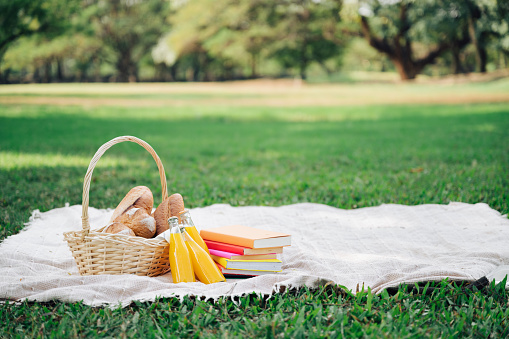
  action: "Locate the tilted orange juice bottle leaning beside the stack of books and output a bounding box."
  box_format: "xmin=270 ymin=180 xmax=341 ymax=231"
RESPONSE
xmin=182 ymin=227 xmax=226 ymax=284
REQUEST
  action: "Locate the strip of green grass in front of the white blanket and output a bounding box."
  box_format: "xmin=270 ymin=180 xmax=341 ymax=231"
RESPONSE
xmin=0 ymin=281 xmax=509 ymax=338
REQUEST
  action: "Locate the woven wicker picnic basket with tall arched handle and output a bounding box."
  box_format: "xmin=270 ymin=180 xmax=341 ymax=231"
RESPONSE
xmin=64 ymin=136 xmax=170 ymax=277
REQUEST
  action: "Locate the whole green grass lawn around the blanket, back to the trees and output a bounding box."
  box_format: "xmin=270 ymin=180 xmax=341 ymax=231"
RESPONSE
xmin=0 ymin=80 xmax=509 ymax=337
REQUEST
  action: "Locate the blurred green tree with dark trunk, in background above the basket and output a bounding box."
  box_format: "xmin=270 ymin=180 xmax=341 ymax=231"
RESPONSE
xmin=83 ymin=0 xmax=170 ymax=82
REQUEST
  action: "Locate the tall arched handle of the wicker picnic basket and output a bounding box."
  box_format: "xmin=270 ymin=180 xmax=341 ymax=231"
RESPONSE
xmin=81 ymin=135 xmax=168 ymax=236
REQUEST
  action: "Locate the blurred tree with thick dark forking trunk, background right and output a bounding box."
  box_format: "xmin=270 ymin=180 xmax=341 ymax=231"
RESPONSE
xmin=359 ymin=0 xmax=471 ymax=80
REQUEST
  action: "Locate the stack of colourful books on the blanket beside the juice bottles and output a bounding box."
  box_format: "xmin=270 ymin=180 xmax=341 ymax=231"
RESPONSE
xmin=200 ymin=225 xmax=291 ymax=277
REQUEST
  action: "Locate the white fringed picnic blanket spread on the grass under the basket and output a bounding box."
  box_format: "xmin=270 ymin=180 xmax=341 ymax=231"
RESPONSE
xmin=0 ymin=203 xmax=509 ymax=307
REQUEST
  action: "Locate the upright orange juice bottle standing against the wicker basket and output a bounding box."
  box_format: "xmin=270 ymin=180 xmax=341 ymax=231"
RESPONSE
xmin=168 ymin=217 xmax=196 ymax=283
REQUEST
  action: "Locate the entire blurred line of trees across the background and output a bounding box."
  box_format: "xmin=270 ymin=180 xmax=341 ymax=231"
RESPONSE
xmin=0 ymin=0 xmax=509 ymax=83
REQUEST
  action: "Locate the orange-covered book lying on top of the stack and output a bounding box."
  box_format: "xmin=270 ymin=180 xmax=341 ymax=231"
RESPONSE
xmin=200 ymin=225 xmax=291 ymax=248
